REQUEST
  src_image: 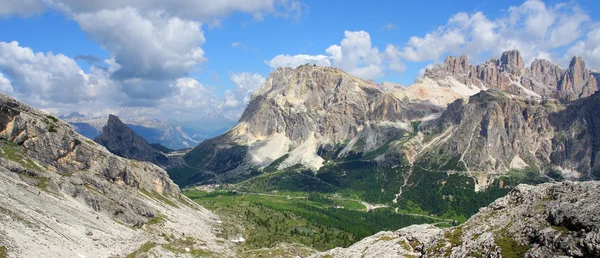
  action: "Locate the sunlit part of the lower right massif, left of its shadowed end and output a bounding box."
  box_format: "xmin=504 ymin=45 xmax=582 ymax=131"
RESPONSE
xmin=421 ymin=90 xmax=555 ymax=185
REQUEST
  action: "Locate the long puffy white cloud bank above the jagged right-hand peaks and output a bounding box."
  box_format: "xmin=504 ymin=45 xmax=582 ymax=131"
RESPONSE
xmin=386 ymin=0 xmax=591 ymax=67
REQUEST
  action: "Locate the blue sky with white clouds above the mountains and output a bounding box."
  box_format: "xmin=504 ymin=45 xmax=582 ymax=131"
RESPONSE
xmin=0 ymin=0 xmax=600 ymax=121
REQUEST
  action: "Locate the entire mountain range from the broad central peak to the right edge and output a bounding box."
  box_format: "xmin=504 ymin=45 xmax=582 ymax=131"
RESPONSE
xmin=172 ymin=50 xmax=598 ymax=189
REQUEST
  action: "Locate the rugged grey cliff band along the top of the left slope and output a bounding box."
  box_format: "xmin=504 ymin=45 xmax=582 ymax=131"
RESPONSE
xmin=0 ymin=94 xmax=179 ymax=226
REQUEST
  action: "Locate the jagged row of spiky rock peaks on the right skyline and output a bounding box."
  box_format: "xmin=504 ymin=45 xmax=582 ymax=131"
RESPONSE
xmin=424 ymin=50 xmax=598 ymax=102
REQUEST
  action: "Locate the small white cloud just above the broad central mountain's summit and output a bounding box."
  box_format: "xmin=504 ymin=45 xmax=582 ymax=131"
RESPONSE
xmin=265 ymin=31 xmax=385 ymax=79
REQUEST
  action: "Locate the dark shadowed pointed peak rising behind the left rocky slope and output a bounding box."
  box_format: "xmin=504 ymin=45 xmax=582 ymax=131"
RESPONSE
xmin=94 ymin=115 xmax=168 ymax=166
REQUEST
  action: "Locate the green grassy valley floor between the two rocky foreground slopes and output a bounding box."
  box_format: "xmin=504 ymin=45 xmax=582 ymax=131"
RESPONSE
xmin=184 ymin=190 xmax=434 ymax=250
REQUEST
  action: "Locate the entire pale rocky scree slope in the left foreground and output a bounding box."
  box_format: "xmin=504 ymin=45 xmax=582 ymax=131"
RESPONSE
xmin=0 ymin=94 xmax=231 ymax=257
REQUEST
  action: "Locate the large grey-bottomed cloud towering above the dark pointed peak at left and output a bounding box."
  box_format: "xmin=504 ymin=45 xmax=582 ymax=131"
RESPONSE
xmin=74 ymin=8 xmax=206 ymax=80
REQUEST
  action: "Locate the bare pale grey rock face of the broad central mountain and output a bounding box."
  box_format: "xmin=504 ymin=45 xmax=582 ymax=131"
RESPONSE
xmin=239 ymin=65 xmax=423 ymax=143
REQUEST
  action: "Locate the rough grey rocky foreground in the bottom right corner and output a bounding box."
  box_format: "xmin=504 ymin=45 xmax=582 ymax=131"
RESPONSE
xmin=314 ymin=182 xmax=600 ymax=257
